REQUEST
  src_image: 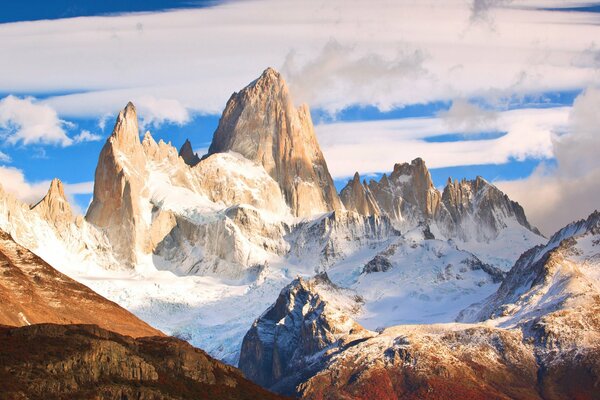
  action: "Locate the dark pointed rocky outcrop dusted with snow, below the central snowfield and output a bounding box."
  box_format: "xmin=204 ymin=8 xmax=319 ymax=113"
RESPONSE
xmin=239 ymin=274 xmax=369 ymax=394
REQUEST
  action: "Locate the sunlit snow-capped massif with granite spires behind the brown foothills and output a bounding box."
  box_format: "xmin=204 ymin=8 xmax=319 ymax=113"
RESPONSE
xmin=0 ymin=69 xmax=545 ymax=372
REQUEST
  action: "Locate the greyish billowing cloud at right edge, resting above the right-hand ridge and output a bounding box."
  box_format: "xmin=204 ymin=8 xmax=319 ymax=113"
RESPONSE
xmin=497 ymin=88 xmax=600 ymax=234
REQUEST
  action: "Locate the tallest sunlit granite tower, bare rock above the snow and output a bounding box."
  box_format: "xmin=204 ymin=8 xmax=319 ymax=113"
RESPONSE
xmin=208 ymin=68 xmax=342 ymax=217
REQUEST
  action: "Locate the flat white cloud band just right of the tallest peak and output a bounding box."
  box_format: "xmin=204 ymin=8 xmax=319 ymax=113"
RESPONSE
xmin=315 ymin=107 xmax=570 ymax=178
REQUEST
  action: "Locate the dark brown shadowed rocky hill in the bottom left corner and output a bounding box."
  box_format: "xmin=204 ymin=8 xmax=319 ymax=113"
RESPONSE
xmin=0 ymin=324 xmax=280 ymax=400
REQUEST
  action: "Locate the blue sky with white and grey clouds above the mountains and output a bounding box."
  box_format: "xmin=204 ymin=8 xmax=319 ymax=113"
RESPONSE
xmin=0 ymin=0 xmax=600 ymax=234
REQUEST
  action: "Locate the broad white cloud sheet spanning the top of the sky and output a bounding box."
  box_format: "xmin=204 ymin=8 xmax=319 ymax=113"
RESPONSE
xmin=0 ymin=0 xmax=600 ymax=117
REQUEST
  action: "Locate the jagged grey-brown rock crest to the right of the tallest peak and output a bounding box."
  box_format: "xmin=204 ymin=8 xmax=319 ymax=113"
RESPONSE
xmin=341 ymin=158 xmax=540 ymax=242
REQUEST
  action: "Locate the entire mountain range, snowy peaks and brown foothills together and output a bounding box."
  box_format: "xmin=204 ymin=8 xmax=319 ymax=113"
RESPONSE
xmin=0 ymin=68 xmax=600 ymax=399
